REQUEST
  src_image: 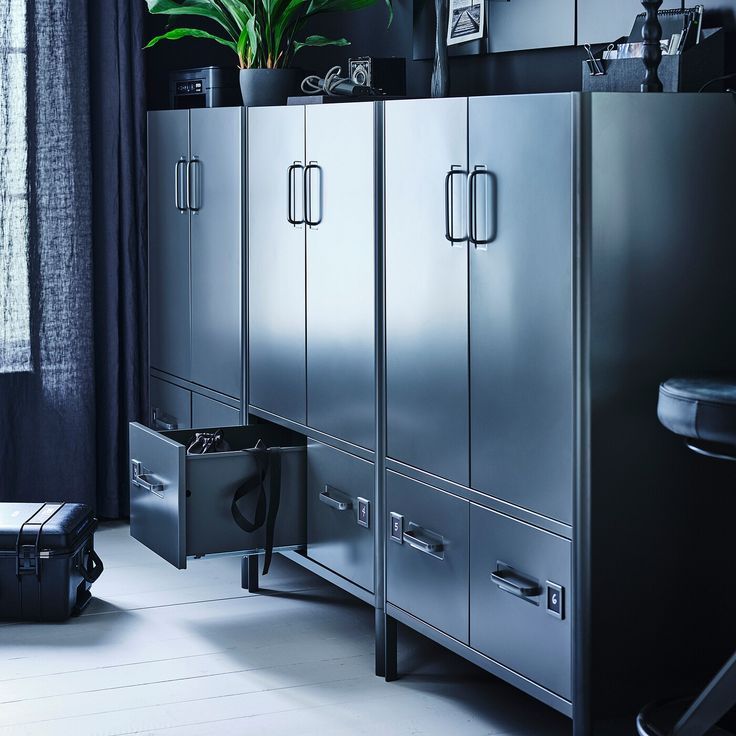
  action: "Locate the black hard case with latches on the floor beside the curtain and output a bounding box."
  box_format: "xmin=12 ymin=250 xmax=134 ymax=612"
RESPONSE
xmin=0 ymin=503 xmax=102 ymax=621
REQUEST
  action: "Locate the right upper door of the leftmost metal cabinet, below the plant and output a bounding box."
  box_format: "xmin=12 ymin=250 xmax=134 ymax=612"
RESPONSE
xmin=189 ymin=107 xmax=243 ymax=398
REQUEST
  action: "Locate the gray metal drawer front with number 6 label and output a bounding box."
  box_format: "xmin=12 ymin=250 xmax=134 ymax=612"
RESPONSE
xmin=470 ymin=504 xmax=572 ymax=700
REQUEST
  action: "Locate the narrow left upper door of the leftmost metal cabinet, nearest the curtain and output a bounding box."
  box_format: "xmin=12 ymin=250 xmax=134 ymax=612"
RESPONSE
xmin=148 ymin=110 xmax=190 ymax=386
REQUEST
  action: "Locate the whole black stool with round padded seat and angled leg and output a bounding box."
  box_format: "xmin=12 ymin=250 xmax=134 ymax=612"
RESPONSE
xmin=636 ymin=376 xmax=736 ymax=736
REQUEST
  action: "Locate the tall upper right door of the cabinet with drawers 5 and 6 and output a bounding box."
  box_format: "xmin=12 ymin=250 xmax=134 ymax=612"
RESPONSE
xmin=469 ymin=94 xmax=574 ymax=523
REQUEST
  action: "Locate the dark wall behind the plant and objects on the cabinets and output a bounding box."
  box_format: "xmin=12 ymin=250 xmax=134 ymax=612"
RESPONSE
xmin=140 ymin=0 xmax=736 ymax=108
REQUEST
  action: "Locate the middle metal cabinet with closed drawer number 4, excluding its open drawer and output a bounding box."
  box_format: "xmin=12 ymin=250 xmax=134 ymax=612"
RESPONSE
xmin=248 ymin=102 xmax=382 ymax=603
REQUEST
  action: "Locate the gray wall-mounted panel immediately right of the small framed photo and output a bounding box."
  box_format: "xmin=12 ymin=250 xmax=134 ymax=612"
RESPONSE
xmin=486 ymin=0 xmax=576 ymax=52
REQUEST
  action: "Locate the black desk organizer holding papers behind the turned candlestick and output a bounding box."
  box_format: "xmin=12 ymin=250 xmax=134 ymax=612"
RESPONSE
xmin=582 ymin=28 xmax=724 ymax=92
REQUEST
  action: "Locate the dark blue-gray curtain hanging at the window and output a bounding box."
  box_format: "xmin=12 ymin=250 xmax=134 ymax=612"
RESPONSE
xmin=0 ymin=0 xmax=146 ymax=517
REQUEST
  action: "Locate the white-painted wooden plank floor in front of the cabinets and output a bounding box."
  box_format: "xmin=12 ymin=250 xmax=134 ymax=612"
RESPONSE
xmin=0 ymin=524 xmax=570 ymax=736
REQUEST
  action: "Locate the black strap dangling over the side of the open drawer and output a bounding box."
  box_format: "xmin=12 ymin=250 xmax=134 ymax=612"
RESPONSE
xmin=230 ymin=441 xmax=281 ymax=575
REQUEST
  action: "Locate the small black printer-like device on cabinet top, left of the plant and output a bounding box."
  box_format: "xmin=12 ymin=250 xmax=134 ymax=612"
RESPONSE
xmin=169 ymin=66 xmax=242 ymax=110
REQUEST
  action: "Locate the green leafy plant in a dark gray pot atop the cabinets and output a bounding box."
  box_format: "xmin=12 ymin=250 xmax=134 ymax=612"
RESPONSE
xmin=146 ymin=0 xmax=393 ymax=106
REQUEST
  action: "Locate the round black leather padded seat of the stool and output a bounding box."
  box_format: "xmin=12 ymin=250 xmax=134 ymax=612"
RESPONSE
xmin=657 ymin=375 xmax=736 ymax=452
